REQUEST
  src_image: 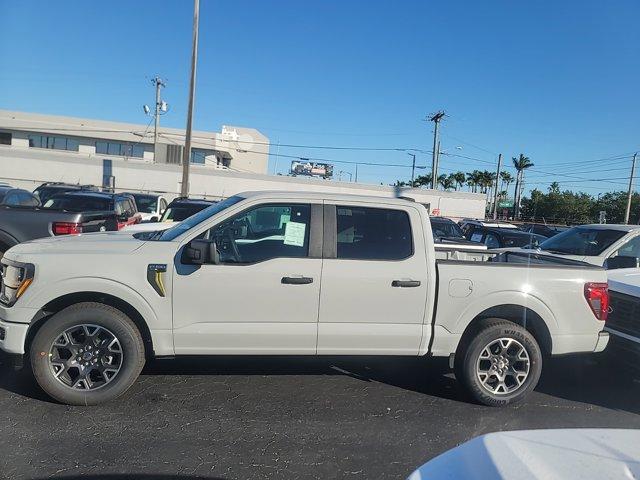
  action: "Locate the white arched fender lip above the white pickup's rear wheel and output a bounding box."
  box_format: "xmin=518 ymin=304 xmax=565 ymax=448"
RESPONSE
xmin=452 ymin=291 xmax=558 ymax=334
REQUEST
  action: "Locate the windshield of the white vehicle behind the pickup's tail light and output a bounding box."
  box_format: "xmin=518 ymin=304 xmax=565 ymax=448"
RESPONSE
xmin=540 ymin=227 xmax=627 ymax=256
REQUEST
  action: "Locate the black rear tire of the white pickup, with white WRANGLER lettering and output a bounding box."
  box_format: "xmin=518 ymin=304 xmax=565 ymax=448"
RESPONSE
xmin=454 ymin=318 xmax=542 ymax=407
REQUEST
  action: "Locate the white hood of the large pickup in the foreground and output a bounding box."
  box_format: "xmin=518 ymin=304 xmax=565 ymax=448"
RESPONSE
xmin=5 ymin=232 xmax=145 ymax=260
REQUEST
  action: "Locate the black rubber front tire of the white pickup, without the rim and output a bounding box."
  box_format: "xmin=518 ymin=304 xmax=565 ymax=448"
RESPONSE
xmin=30 ymin=302 xmax=145 ymax=405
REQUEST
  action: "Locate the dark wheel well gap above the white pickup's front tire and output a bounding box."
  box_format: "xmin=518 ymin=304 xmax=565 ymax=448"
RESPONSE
xmin=25 ymin=292 xmax=153 ymax=358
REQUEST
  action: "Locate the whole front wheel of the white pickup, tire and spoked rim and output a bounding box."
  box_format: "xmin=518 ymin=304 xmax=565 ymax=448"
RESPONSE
xmin=30 ymin=302 xmax=145 ymax=405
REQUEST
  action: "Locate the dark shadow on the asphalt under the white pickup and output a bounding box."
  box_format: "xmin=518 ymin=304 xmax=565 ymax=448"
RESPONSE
xmin=0 ymin=354 xmax=640 ymax=414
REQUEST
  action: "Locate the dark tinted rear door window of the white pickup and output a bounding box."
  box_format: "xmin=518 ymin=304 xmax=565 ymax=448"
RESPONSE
xmin=336 ymin=205 xmax=413 ymax=260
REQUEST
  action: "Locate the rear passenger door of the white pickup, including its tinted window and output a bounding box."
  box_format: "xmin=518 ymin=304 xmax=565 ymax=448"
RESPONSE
xmin=318 ymin=202 xmax=428 ymax=355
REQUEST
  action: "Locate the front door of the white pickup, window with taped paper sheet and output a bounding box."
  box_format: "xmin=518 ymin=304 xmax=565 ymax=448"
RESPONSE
xmin=173 ymin=203 xmax=322 ymax=354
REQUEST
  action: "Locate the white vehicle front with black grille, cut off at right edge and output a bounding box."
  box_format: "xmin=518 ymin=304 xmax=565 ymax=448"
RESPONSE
xmin=605 ymin=268 xmax=640 ymax=367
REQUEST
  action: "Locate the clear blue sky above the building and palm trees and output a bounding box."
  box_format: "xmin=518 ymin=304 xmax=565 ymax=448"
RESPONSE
xmin=0 ymin=0 xmax=640 ymax=194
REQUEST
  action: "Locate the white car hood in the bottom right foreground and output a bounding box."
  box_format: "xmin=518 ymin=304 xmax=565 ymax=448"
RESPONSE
xmin=408 ymin=429 xmax=640 ymax=480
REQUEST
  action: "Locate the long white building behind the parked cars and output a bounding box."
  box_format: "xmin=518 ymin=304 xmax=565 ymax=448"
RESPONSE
xmin=0 ymin=110 xmax=486 ymax=218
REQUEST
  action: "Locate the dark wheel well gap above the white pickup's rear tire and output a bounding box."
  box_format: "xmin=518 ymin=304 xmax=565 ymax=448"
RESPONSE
xmin=460 ymin=304 xmax=553 ymax=356
